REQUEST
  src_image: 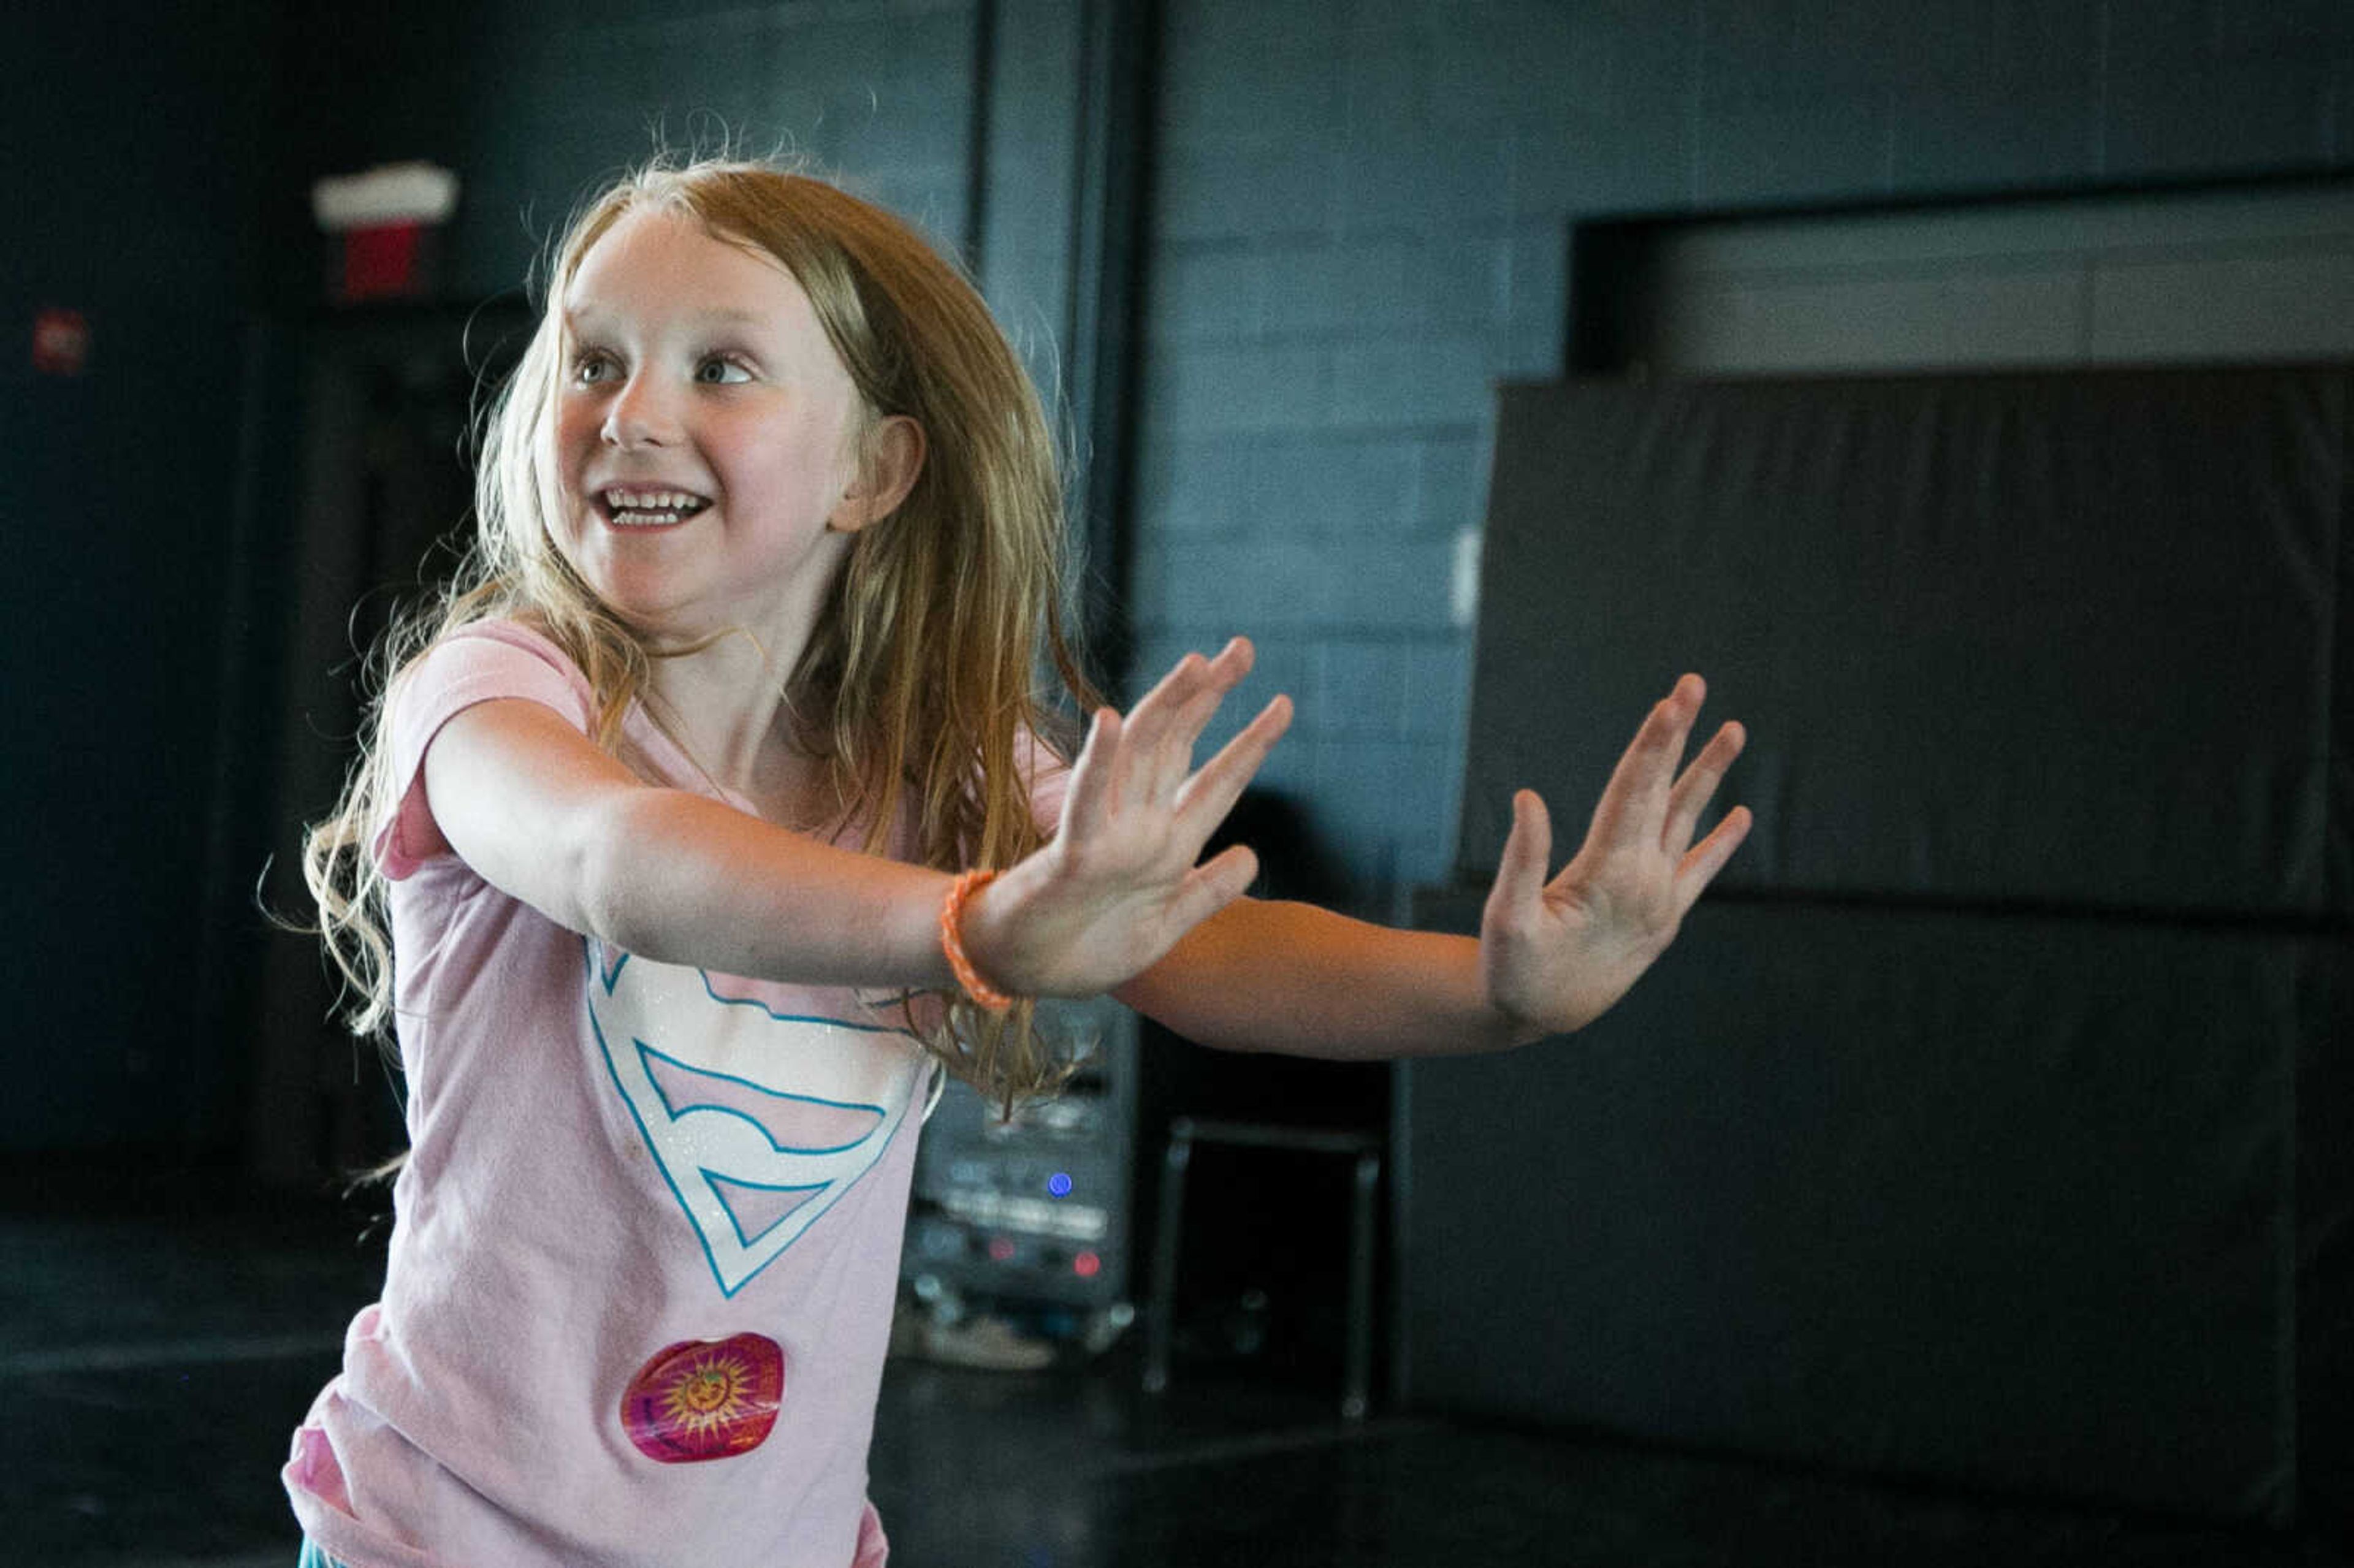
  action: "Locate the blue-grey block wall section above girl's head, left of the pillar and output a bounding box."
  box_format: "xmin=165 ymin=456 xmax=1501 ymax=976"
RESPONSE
xmin=297 ymin=0 xmax=979 ymax=315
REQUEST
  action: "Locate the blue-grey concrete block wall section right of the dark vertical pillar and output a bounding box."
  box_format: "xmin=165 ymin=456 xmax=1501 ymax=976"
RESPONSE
xmin=1132 ymin=0 xmax=2354 ymax=907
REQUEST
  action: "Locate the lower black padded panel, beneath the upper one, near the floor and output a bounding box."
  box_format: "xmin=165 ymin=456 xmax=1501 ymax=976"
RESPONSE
xmin=1398 ymin=895 xmax=2297 ymax=1518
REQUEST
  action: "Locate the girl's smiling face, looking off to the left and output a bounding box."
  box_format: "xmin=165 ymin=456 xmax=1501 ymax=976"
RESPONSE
xmin=555 ymin=210 xmax=869 ymax=645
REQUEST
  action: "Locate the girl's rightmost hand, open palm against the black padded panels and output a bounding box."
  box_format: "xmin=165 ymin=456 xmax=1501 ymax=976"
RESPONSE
xmin=1479 ymin=676 xmax=1751 ymax=1041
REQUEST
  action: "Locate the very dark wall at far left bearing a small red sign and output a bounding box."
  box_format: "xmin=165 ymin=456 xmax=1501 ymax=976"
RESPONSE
xmin=0 ymin=0 xmax=285 ymax=1149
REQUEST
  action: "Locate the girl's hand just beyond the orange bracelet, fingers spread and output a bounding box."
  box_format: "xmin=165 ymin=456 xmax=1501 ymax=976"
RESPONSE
xmin=963 ymin=638 xmax=1292 ymax=996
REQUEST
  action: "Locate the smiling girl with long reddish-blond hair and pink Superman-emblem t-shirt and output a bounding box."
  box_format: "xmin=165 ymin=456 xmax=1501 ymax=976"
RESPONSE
xmin=285 ymin=162 xmax=1749 ymax=1568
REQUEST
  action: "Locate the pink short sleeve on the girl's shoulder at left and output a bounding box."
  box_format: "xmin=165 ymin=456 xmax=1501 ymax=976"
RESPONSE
xmin=372 ymin=622 xmax=596 ymax=883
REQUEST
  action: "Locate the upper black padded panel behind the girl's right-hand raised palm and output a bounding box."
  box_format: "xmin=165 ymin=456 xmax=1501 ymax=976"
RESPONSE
xmin=1462 ymin=367 xmax=2354 ymax=916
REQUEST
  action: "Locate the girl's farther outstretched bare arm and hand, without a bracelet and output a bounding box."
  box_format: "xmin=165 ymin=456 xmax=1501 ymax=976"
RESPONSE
xmin=1118 ymin=676 xmax=1751 ymax=1057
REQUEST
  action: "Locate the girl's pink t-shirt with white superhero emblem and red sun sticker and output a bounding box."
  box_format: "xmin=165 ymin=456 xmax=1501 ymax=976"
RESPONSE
xmin=285 ymin=622 xmax=1040 ymax=1568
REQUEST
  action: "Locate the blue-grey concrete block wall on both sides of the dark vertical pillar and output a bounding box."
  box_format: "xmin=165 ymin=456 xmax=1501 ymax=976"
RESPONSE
xmin=280 ymin=0 xmax=2354 ymax=907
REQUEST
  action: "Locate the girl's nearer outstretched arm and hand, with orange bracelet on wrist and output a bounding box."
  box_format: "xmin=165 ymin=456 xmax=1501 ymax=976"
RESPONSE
xmin=409 ymin=638 xmax=1290 ymax=996
